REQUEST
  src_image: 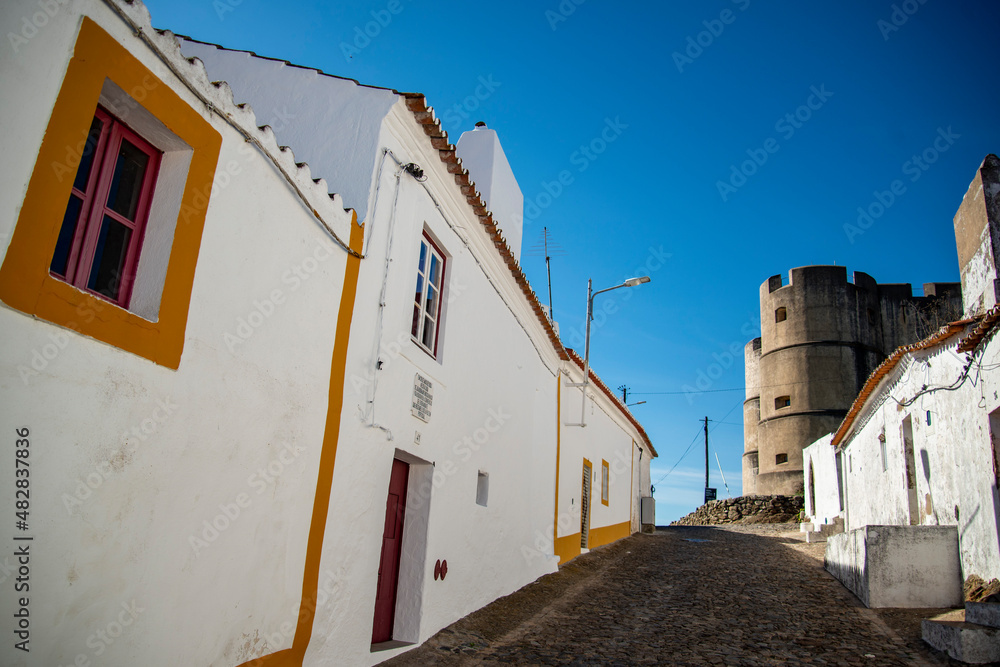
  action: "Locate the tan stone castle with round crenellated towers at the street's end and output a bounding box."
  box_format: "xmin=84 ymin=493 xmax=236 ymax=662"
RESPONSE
xmin=743 ymin=266 xmax=962 ymax=495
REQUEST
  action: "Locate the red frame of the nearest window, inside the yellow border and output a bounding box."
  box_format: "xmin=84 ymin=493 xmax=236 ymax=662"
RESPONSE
xmin=49 ymin=107 xmax=162 ymax=309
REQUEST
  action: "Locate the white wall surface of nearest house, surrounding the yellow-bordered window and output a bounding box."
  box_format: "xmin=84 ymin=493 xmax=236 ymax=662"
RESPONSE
xmin=0 ymin=1 xmax=358 ymax=667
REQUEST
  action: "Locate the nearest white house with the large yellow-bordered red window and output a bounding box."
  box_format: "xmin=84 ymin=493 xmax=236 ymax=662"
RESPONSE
xmin=0 ymin=1 xmax=362 ymax=667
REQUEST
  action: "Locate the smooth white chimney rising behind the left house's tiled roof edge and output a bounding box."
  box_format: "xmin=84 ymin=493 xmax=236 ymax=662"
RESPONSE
xmin=456 ymin=122 xmax=524 ymax=262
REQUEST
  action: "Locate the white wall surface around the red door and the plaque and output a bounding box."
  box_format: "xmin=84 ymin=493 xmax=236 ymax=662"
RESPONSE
xmin=298 ymin=100 xmax=558 ymax=665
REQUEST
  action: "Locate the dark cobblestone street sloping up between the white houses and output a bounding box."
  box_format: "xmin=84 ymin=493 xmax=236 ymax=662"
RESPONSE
xmin=384 ymin=525 xmax=960 ymax=667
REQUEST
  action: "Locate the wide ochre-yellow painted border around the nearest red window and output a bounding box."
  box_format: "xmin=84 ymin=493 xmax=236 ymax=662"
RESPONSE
xmin=0 ymin=17 xmax=222 ymax=369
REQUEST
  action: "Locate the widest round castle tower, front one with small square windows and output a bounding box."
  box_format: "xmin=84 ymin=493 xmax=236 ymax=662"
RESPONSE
xmin=756 ymin=266 xmax=884 ymax=495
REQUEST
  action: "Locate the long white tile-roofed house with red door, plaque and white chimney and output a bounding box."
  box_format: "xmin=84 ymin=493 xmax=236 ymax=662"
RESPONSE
xmin=176 ymin=40 xmax=655 ymax=664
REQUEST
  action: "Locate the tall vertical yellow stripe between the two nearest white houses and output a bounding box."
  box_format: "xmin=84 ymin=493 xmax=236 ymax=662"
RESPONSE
xmin=239 ymin=219 xmax=365 ymax=667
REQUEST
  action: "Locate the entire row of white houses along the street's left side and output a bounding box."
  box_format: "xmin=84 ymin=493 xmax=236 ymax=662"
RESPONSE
xmin=0 ymin=0 xmax=655 ymax=666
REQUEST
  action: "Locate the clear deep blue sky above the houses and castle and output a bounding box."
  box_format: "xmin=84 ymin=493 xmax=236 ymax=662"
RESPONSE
xmin=146 ymin=0 xmax=1000 ymax=523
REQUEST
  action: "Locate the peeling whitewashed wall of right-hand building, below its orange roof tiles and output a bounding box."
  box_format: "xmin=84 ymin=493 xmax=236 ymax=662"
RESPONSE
xmin=843 ymin=338 xmax=1000 ymax=579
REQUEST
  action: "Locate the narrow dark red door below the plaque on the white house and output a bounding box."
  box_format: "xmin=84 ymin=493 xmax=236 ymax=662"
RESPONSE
xmin=372 ymin=459 xmax=410 ymax=644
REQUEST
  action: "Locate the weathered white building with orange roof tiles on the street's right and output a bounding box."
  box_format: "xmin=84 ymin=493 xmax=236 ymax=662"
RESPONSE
xmin=804 ymin=155 xmax=1000 ymax=606
